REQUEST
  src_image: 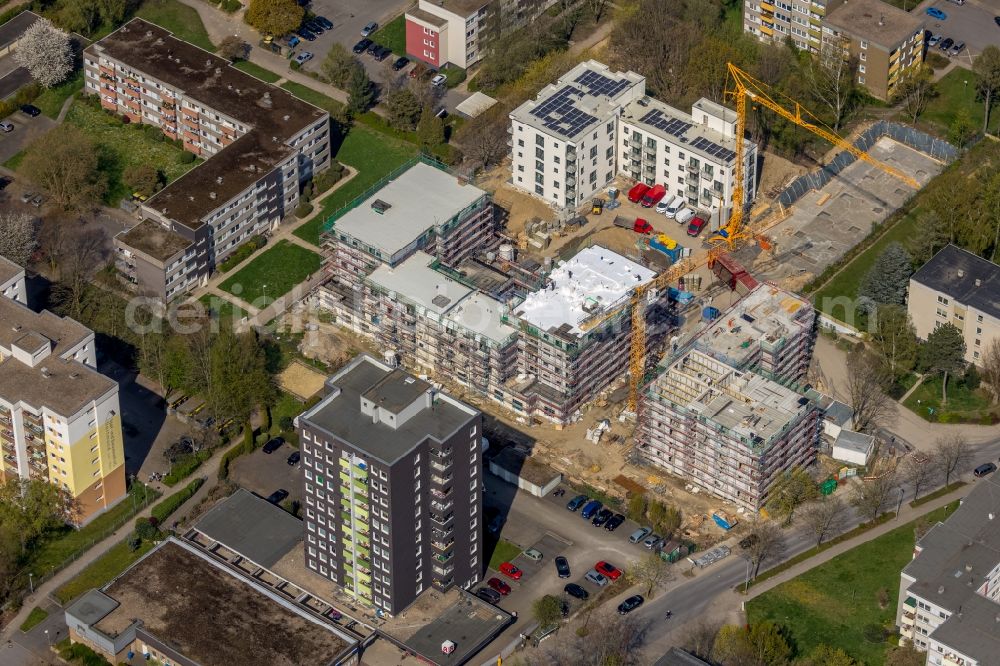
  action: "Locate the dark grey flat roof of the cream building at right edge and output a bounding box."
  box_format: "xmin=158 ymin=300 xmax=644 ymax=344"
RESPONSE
xmin=910 ymin=245 xmax=1000 ymax=319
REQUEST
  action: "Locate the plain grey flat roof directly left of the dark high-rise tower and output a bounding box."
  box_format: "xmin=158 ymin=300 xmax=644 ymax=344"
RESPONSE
xmin=194 ymin=488 xmax=302 ymax=569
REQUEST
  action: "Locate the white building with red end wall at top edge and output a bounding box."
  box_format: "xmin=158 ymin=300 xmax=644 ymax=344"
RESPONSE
xmin=406 ymin=0 xmax=556 ymax=68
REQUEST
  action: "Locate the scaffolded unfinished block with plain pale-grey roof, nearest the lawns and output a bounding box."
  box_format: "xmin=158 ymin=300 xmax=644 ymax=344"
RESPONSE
xmin=319 ymin=160 xmax=500 ymax=326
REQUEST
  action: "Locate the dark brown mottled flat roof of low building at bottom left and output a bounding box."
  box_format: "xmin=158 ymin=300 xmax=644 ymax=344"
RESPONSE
xmin=94 ymin=537 xmax=349 ymax=666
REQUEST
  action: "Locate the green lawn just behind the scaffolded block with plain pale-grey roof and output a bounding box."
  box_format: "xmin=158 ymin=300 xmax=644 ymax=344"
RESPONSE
xmin=294 ymin=125 xmax=417 ymax=246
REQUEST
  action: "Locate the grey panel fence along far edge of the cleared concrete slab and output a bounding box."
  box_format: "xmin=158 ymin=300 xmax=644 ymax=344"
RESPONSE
xmin=778 ymin=120 xmax=959 ymax=206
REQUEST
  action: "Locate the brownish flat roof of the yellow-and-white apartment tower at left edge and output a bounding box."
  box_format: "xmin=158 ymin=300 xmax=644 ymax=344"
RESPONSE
xmin=0 ymin=356 xmax=118 ymax=418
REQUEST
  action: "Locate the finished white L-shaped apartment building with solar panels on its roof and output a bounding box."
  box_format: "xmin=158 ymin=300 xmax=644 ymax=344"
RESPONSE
xmin=510 ymin=60 xmax=757 ymax=220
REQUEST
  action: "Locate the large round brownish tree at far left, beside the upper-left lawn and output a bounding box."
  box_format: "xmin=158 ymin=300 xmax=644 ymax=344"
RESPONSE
xmin=18 ymin=123 xmax=107 ymax=211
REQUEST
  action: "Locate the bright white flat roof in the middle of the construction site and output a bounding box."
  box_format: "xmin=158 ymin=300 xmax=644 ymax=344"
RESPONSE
xmin=514 ymin=245 xmax=656 ymax=335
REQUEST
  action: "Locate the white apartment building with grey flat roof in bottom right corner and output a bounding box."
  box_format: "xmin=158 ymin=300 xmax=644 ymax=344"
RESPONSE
xmin=896 ymin=475 xmax=1000 ymax=666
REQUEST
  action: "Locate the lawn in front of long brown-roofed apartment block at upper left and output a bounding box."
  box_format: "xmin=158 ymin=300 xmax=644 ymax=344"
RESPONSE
xmin=66 ymin=100 xmax=201 ymax=205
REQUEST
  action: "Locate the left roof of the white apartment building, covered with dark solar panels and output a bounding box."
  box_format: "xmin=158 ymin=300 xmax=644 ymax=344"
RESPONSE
xmin=510 ymin=60 xmax=646 ymax=141
